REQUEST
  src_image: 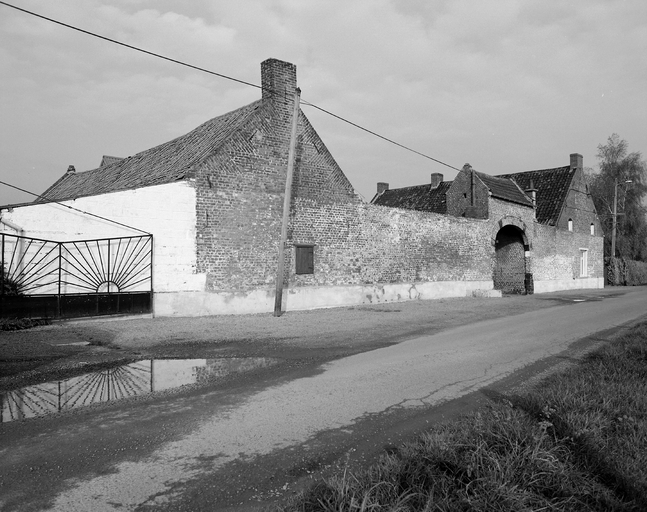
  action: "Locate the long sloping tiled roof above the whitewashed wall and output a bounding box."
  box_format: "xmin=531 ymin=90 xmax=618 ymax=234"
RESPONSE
xmin=38 ymin=100 xmax=262 ymax=202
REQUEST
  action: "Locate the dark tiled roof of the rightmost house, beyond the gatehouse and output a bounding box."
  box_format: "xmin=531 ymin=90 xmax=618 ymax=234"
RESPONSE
xmin=498 ymin=166 xmax=575 ymax=226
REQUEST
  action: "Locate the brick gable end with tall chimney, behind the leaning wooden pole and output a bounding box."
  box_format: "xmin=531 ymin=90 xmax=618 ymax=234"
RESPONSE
xmin=196 ymin=59 xmax=359 ymax=291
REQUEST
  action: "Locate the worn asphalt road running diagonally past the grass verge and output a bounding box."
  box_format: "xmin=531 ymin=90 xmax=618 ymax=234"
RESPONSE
xmin=0 ymin=287 xmax=647 ymax=512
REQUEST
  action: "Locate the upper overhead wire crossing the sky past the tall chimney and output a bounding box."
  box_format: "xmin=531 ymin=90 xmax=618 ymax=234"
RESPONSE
xmin=0 ymin=0 xmax=460 ymax=171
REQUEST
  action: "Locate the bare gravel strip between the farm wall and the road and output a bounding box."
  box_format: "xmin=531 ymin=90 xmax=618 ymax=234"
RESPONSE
xmin=0 ymin=288 xmax=623 ymax=391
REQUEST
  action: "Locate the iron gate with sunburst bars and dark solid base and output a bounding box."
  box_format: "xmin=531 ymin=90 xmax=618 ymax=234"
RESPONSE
xmin=0 ymin=233 xmax=153 ymax=318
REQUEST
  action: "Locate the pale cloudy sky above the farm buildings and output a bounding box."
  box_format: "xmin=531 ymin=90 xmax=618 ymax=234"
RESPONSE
xmin=0 ymin=0 xmax=647 ymax=204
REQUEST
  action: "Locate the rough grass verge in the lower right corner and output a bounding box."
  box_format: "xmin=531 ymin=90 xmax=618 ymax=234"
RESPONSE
xmin=276 ymin=323 xmax=647 ymax=512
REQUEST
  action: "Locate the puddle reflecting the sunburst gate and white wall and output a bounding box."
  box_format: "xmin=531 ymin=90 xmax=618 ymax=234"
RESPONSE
xmin=0 ymin=357 xmax=276 ymax=423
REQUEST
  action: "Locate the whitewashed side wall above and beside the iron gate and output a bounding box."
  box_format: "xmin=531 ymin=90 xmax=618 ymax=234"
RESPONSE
xmin=0 ymin=181 xmax=205 ymax=293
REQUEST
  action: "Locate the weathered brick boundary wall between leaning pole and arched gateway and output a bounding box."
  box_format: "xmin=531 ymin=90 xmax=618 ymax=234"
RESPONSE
xmin=290 ymin=199 xmax=493 ymax=286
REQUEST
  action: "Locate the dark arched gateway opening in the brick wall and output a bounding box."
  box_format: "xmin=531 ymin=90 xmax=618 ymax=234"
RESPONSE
xmin=493 ymin=225 xmax=528 ymax=293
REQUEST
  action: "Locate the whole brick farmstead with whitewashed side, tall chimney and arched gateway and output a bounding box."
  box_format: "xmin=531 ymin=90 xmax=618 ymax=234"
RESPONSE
xmin=0 ymin=59 xmax=603 ymax=316
